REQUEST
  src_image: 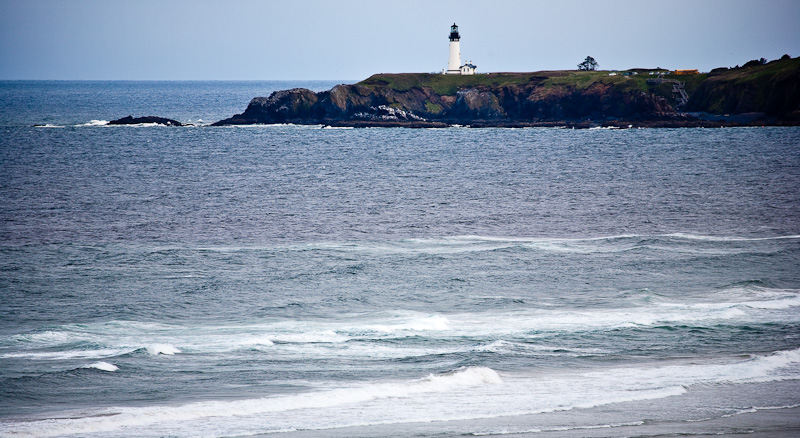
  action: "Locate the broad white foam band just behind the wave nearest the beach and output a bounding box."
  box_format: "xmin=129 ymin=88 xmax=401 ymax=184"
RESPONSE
xmin=0 ymin=294 xmax=800 ymax=366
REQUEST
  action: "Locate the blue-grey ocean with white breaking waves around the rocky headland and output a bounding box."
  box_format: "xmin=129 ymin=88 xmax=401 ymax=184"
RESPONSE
xmin=0 ymin=81 xmax=800 ymax=437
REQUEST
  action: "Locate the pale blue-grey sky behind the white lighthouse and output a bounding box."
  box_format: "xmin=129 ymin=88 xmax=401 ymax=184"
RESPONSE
xmin=0 ymin=0 xmax=800 ymax=80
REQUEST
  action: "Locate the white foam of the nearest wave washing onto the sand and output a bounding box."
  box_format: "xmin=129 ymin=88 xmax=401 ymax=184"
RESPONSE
xmin=6 ymin=350 xmax=800 ymax=436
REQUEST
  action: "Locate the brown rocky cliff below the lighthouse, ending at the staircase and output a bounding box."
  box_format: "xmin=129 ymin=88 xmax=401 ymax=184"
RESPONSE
xmin=216 ymin=74 xmax=675 ymax=125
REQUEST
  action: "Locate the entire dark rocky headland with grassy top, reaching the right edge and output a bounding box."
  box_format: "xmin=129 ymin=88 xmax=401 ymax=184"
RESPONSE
xmin=215 ymin=60 xmax=800 ymax=126
